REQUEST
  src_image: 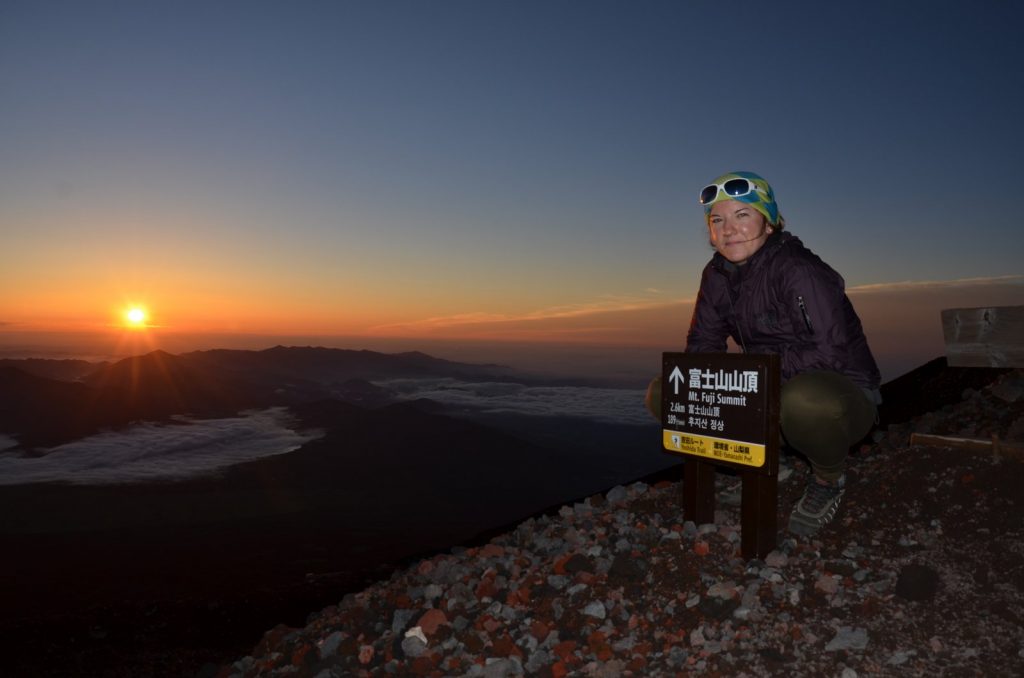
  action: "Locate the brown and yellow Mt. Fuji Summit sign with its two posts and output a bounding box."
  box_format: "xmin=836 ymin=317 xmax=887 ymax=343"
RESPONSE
xmin=662 ymin=353 xmax=780 ymax=559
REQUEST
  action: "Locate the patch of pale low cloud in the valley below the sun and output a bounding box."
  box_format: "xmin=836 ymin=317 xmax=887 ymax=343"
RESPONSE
xmin=0 ymin=408 xmax=319 ymax=485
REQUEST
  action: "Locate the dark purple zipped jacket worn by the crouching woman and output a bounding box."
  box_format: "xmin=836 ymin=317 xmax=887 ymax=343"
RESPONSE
xmin=686 ymin=230 xmax=881 ymax=391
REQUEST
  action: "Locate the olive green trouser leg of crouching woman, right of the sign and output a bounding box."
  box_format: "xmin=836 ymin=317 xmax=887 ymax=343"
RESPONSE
xmin=779 ymin=371 xmax=878 ymax=480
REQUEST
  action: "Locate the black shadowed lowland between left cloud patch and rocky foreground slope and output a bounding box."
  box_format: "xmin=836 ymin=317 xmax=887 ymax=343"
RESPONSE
xmin=0 ymin=401 xmax=647 ymax=676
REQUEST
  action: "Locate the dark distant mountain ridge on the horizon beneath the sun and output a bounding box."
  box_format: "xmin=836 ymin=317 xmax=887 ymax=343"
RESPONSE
xmin=0 ymin=346 xmax=514 ymax=450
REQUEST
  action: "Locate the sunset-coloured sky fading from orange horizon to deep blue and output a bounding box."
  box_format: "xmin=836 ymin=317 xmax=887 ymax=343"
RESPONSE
xmin=0 ymin=0 xmax=1024 ymax=358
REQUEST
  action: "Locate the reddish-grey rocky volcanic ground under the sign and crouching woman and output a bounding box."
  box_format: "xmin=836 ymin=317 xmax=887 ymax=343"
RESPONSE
xmin=216 ymin=371 xmax=1024 ymax=678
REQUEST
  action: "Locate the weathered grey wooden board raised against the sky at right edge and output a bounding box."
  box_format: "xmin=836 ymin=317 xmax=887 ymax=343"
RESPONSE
xmin=942 ymin=306 xmax=1024 ymax=368
